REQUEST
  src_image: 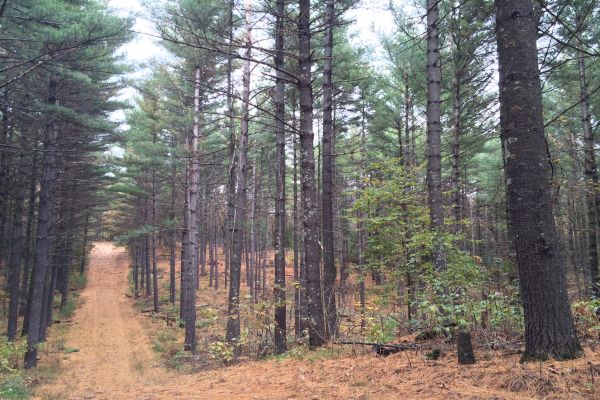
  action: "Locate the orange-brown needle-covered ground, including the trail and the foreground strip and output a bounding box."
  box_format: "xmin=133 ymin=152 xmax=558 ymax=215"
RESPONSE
xmin=34 ymin=243 xmax=600 ymax=400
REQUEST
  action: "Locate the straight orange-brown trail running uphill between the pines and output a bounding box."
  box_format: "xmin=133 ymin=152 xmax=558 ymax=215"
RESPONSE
xmin=38 ymin=243 xmax=169 ymax=399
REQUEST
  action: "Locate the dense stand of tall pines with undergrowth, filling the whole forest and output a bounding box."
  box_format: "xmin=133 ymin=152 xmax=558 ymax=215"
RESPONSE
xmin=0 ymin=0 xmax=600 ymax=390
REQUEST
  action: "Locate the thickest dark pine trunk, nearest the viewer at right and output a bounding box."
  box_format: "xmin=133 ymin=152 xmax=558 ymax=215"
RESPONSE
xmin=496 ymin=0 xmax=582 ymax=360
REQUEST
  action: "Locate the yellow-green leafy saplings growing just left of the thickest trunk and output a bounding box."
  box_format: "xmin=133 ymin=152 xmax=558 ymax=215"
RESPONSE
xmin=353 ymin=160 xmax=508 ymax=334
